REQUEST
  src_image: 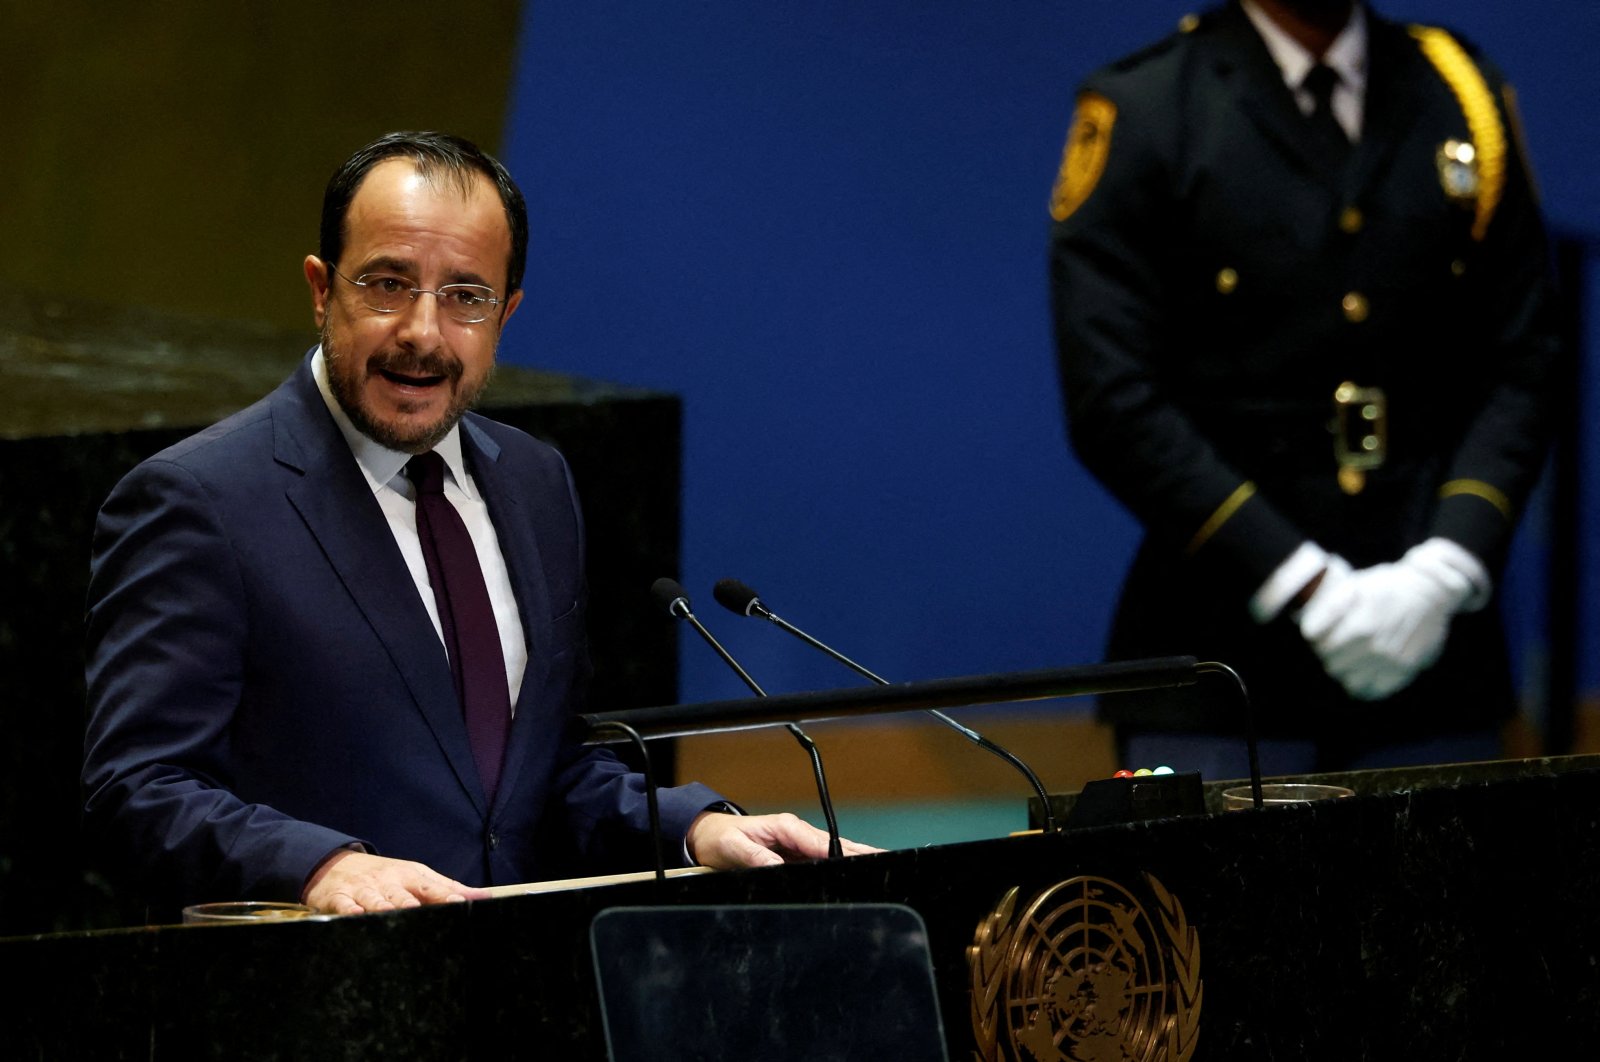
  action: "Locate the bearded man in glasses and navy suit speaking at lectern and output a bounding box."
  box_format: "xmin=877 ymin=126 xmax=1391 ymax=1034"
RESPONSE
xmin=83 ymin=133 xmax=870 ymax=913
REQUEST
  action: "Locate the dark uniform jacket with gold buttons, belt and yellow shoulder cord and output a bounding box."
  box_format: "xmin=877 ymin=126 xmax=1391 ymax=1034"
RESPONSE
xmin=1051 ymin=5 xmax=1555 ymax=744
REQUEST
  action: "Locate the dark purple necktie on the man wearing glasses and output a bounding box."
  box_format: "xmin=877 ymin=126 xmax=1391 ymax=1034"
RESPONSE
xmin=405 ymin=451 xmax=510 ymax=803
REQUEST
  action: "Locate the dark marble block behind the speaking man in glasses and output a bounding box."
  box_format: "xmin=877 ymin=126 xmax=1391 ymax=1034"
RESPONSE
xmin=0 ymin=289 xmax=680 ymax=934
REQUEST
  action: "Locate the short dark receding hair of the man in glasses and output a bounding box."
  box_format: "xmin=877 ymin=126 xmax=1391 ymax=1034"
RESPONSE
xmin=320 ymin=133 xmax=528 ymax=296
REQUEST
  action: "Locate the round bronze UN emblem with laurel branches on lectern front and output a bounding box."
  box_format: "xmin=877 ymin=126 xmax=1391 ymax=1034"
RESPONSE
xmin=966 ymin=873 xmax=1202 ymax=1062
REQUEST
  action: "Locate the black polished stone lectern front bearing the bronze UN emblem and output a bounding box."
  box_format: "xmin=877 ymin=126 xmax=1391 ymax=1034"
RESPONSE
xmin=0 ymin=757 xmax=1600 ymax=1062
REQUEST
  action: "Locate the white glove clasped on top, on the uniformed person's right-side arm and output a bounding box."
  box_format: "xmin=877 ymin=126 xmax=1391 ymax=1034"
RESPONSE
xmin=1299 ymin=539 xmax=1488 ymax=701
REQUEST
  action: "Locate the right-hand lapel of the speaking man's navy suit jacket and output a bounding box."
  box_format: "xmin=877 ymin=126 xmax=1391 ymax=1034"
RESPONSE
xmin=461 ymin=417 xmax=552 ymax=812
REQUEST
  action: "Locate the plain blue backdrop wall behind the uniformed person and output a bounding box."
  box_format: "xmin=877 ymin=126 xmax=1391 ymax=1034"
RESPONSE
xmin=502 ymin=0 xmax=1600 ymax=722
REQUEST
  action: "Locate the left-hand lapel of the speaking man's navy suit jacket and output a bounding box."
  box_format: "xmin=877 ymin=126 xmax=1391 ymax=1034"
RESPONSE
xmin=272 ymin=360 xmax=486 ymax=812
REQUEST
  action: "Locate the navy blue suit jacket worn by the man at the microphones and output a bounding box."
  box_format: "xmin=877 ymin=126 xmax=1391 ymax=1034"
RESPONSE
xmin=83 ymin=358 xmax=718 ymax=902
